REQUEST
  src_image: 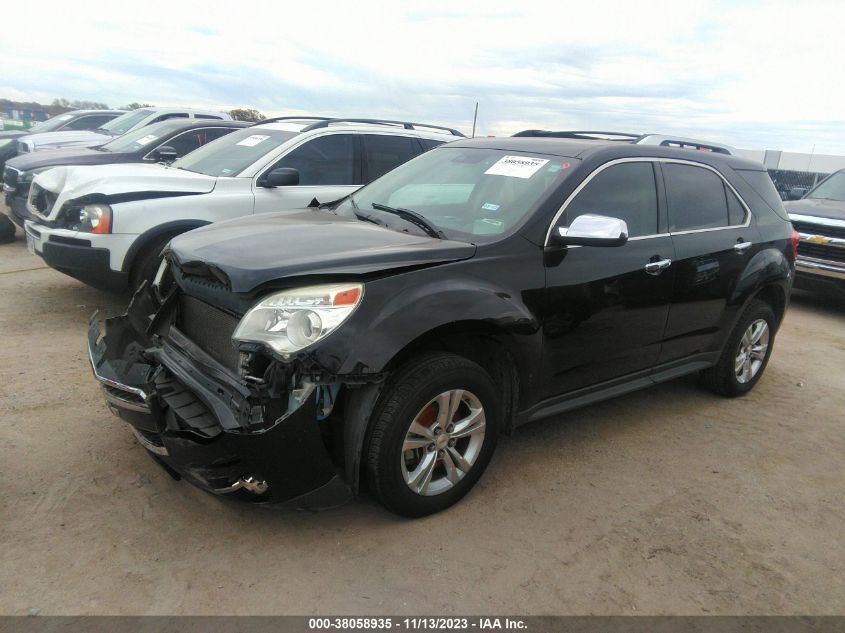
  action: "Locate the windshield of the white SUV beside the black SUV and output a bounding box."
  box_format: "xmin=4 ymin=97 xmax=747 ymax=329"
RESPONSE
xmin=172 ymin=127 xmax=299 ymax=176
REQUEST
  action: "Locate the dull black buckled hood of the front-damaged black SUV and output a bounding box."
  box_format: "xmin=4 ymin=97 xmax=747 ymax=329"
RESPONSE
xmin=170 ymin=210 xmax=476 ymax=292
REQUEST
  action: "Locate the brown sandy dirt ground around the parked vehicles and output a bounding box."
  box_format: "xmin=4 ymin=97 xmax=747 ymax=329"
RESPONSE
xmin=0 ymin=220 xmax=845 ymax=615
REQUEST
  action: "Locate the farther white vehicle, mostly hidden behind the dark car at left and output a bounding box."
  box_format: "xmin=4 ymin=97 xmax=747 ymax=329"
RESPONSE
xmin=18 ymin=108 xmax=232 ymax=154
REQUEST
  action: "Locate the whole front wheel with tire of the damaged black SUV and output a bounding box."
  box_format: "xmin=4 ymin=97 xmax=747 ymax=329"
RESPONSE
xmin=365 ymin=353 xmax=501 ymax=517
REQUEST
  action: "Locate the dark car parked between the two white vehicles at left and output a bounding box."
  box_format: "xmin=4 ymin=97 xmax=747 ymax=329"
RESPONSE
xmin=3 ymin=118 xmax=250 ymax=226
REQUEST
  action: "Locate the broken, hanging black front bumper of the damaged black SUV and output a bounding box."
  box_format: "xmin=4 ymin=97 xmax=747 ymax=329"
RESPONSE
xmin=88 ymin=293 xmax=352 ymax=508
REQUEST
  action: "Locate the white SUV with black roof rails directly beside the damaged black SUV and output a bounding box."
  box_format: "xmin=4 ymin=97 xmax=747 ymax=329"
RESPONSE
xmin=25 ymin=117 xmax=463 ymax=291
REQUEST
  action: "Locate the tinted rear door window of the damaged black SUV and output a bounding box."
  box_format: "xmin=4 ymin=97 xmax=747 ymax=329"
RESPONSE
xmin=663 ymin=163 xmax=728 ymax=232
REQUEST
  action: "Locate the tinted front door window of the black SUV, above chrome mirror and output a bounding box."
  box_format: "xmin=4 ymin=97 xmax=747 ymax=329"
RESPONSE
xmin=566 ymin=162 xmax=657 ymax=237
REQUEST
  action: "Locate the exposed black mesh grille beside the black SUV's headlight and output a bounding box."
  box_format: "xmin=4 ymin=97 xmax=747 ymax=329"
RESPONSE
xmin=176 ymin=294 xmax=240 ymax=371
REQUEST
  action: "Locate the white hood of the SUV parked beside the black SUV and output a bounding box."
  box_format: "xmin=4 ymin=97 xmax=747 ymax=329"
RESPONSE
xmin=33 ymin=163 xmax=217 ymax=220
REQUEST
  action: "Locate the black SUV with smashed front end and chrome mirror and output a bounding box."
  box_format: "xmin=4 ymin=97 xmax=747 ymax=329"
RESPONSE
xmin=89 ymin=138 xmax=797 ymax=516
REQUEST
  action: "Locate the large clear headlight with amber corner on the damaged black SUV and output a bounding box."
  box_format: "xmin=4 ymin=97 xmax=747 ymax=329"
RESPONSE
xmin=232 ymin=284 xmax=364 ymax=358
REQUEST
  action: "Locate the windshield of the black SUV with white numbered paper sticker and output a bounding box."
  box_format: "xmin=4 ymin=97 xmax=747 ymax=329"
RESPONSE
xmin=337 ymin=147 xmax=573 ymax=242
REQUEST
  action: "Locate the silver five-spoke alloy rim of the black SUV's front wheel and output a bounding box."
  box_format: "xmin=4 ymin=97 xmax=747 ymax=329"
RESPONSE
xmin=399 ymin=389 xmax=487 ymax=497
